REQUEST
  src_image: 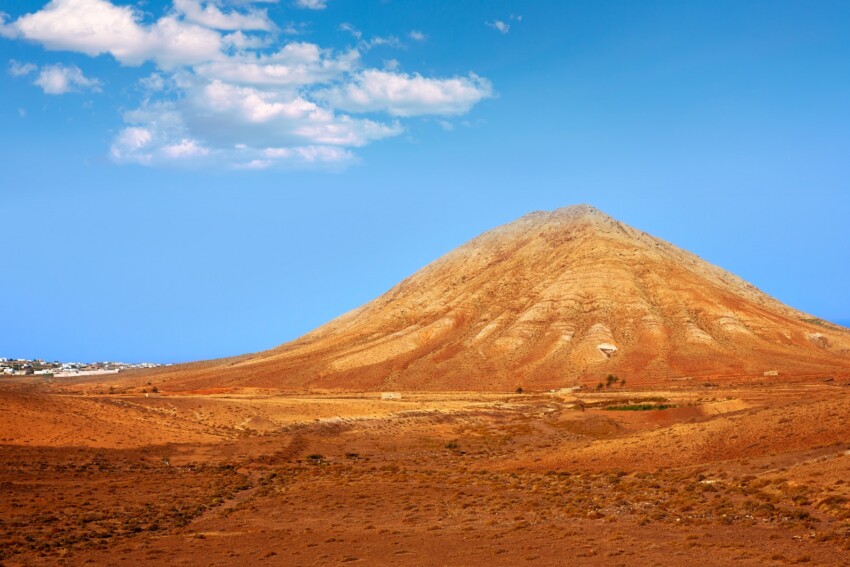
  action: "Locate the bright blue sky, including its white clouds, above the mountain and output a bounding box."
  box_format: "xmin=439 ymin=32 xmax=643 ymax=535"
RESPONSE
xmin=0 ymin=0 xmax=850 ymax=362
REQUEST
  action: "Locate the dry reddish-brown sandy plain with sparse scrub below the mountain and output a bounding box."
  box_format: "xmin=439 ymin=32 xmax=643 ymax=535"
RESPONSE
xmin=0 ymin=383 xmax=850 ymax=565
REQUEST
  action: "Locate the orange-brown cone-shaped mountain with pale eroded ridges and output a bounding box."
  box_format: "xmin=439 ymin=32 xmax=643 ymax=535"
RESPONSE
xmin=144 ymin=205 xmax=850 ymax=391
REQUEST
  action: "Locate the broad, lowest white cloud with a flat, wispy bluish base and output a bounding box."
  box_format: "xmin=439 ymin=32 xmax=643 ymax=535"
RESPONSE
xmin=111 ymin=78 xmax=403 ymax=168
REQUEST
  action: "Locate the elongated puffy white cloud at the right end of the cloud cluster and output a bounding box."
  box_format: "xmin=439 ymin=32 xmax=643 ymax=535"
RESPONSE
xmin=319 ymin=69 xmax=493 ymax=116
